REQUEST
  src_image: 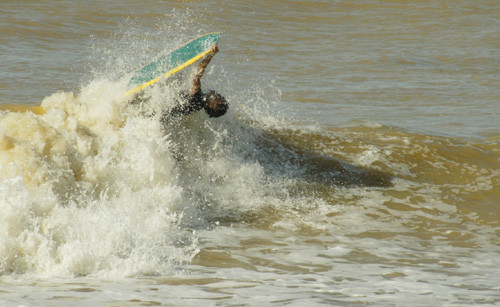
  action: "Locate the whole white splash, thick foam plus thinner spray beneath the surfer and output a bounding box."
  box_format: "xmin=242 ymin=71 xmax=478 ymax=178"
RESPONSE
xmin=0 ymin=25 xmax=282 ymax=277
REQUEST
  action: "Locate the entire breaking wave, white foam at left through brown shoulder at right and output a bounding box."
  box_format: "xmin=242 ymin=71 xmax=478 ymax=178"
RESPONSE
xmin=0 ymin=33 xmax=500 ymax=277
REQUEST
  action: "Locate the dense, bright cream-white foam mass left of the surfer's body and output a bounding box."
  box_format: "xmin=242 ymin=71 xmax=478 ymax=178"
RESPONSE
xmin=0 ymin=82 xmax=203 ymax=276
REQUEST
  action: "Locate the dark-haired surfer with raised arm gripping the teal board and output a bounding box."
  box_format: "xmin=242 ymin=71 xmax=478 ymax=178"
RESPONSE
xmin=168 ymin=44 xmax=229 ymax=118
